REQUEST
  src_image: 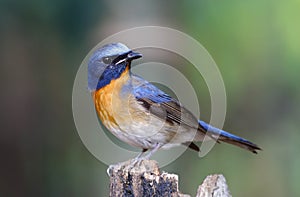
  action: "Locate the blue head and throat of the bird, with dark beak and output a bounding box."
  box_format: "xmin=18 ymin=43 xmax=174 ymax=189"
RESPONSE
xmin=88 ymin=43 xmax=142 ymax=91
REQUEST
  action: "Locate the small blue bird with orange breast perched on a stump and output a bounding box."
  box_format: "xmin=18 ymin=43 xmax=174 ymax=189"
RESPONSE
xmin=87 ymin=43 xmax=261 ymax=161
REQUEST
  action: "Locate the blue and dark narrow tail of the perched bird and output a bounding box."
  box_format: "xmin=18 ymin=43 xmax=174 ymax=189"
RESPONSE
xmin=198 ymin=120 xmax=261 ymax=153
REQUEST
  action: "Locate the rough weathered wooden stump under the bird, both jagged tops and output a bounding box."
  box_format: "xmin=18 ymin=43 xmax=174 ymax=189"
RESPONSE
xmin=107 ymin=160 xmax=231 ymax=197
